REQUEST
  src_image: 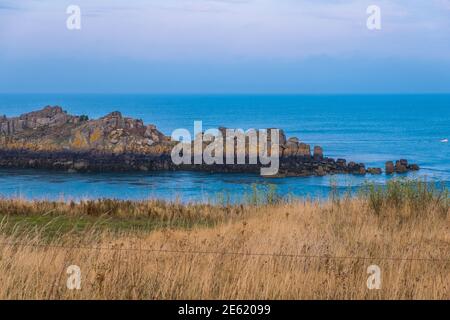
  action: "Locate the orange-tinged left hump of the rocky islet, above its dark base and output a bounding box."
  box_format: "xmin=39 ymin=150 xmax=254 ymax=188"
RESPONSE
xmin=0 ymin=106 xmax=169 ymax=153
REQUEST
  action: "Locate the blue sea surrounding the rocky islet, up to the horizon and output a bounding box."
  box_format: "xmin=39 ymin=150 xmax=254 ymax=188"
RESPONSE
xmin=0 ymin=94 xmax=450 ymax=201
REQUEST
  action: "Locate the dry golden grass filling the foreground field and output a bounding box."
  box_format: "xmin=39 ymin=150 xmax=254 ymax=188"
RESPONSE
xmin=0 ymin=182 xmax=450 ymax=299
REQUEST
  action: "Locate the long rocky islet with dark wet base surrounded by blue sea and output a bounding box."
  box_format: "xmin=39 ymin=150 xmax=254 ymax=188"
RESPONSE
xmin=0 ymin=106 xmax=419 ymax=176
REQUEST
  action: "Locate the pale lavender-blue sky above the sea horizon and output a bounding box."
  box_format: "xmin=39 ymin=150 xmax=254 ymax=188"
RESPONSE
xmin=0 ymin=0 xmax=450 ymax=94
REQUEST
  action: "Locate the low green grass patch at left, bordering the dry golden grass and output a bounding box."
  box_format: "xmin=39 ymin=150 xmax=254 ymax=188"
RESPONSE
xmin=0 ymin=199 xmax=234 ymax=237
